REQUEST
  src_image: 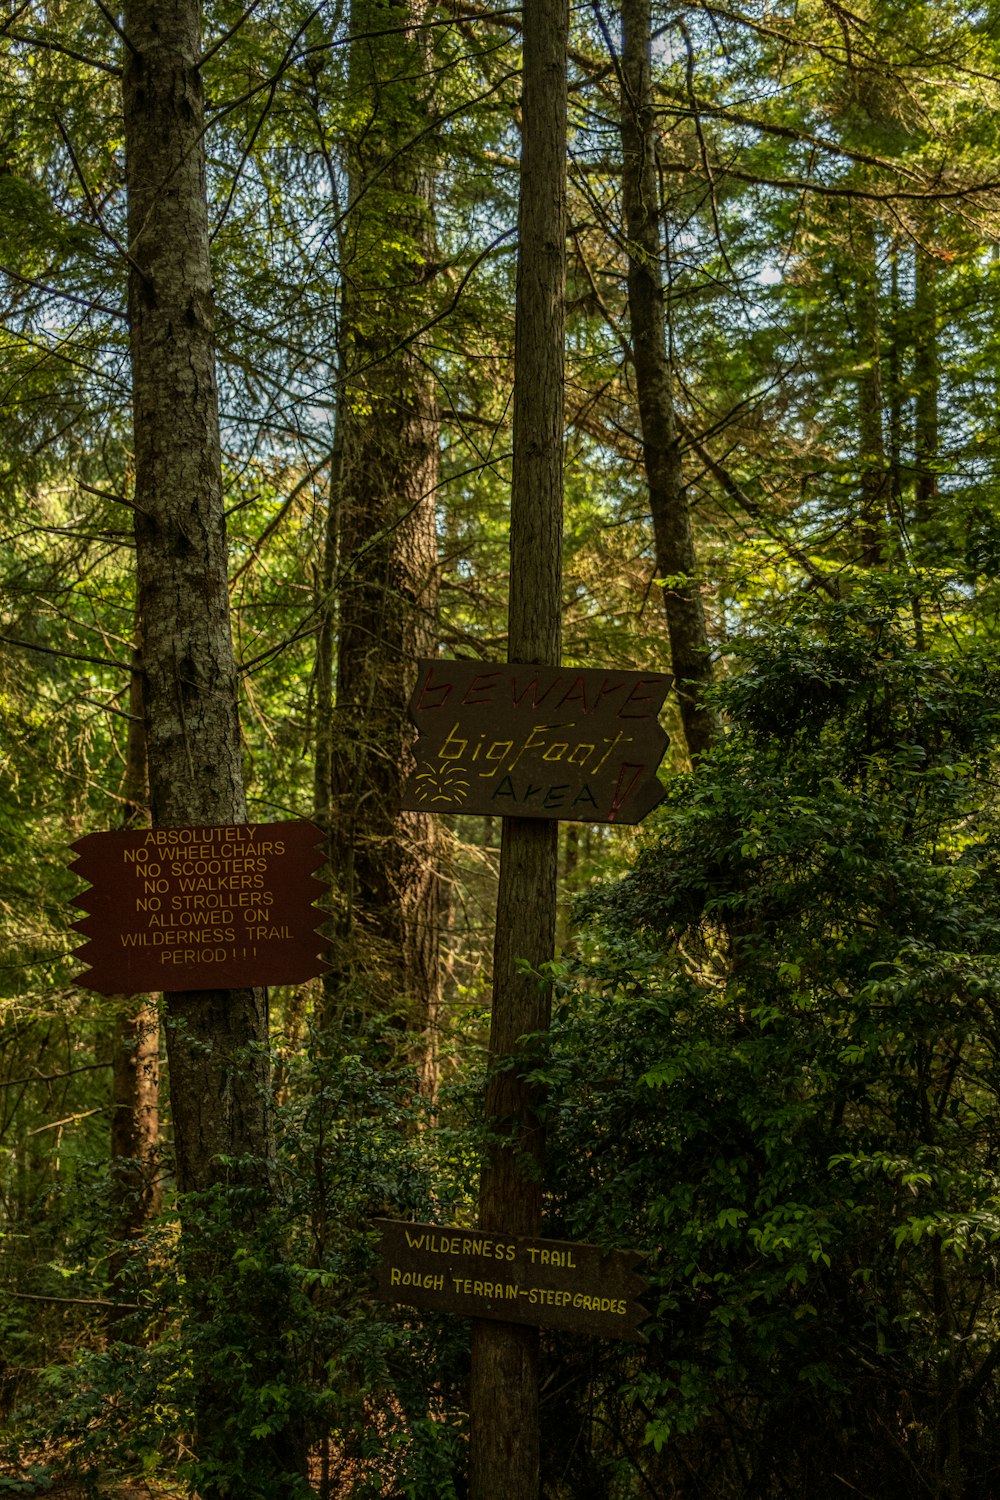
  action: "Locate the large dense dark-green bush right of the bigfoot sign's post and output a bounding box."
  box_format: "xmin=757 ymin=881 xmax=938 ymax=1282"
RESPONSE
xmin=541 ymin=588 xmax=1000 ymax=1497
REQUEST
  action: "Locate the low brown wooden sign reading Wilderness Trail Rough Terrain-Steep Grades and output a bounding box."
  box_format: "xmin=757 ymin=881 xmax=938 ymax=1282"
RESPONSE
xmin=375 ymin=1220 xmax=649 ymax=1343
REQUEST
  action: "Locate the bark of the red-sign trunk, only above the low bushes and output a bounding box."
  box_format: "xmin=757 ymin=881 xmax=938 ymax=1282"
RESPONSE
xmin=124 ymin=0 xmax=270 ymax=1193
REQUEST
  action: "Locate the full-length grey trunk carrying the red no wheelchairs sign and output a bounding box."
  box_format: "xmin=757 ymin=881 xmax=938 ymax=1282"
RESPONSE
xmin=123 ymin=0 xmax=304 ymax=1500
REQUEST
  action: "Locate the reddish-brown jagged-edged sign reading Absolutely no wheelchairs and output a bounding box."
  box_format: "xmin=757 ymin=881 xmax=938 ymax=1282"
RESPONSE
xmin=72 ymin=822 xmax=325 ymax=995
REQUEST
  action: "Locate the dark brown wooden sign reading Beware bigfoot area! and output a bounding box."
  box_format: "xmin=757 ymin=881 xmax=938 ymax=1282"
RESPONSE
xmin=403 ymin=662 xmax=673 ymax=824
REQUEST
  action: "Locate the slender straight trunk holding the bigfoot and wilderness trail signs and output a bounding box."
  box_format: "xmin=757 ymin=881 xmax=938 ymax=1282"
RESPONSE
xmin=469 ymin=0 xmax=568 ymax=1500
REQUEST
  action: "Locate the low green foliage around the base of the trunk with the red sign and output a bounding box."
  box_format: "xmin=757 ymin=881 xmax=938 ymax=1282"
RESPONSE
xmin=3 ymin=1026 xmax=468 ymax=1500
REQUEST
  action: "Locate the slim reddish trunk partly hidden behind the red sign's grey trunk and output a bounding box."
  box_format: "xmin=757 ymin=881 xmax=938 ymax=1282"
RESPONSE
xmin=109 ymin=645 xmax=160 ymax=1323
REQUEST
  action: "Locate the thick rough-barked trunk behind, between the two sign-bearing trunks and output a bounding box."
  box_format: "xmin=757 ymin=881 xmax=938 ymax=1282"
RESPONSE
xmin=327 ymin=0 xmax=441 ymax=1094
